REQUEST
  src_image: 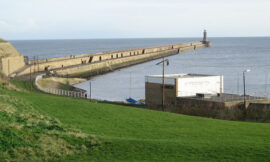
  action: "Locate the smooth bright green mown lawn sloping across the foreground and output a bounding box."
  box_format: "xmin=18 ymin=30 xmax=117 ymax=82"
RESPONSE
xmin=0 ymin=82 xmax=270 ymax=161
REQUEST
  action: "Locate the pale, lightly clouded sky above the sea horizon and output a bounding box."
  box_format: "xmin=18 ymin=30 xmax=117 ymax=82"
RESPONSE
xmin=0 ymin=0 xmax=270 ymax=40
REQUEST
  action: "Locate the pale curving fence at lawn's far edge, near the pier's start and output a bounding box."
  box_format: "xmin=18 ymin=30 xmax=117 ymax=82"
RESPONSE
xmin=35 ymin=74 xmax=86 ymax=98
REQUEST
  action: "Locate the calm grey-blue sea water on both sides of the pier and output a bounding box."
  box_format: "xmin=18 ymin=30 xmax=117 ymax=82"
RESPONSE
xmin=11 ymin=37 xmax=270 ymax=101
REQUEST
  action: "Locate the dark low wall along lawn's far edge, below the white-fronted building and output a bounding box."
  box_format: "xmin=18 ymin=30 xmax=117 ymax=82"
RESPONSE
xmin=146 ymin=95 xmax=270 ymax=121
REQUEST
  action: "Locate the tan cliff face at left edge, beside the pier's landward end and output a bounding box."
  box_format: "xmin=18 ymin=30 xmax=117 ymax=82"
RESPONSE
xmin=0 ymin=39 xmax=25 ymax=76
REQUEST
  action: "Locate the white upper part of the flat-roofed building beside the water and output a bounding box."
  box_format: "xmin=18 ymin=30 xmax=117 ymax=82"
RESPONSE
xmin=145 ymin=74 xmax=223 ymax=97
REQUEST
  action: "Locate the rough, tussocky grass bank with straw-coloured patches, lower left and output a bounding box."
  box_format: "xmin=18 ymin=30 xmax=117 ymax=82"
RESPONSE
xmin=0 ymin=83 xmax=98 ymax=161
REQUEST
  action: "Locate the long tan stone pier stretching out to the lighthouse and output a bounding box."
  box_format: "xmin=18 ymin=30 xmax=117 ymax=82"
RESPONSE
xmin=16 ymin=41 xmax=210 ymax=77
